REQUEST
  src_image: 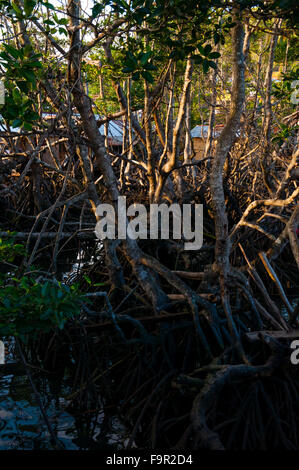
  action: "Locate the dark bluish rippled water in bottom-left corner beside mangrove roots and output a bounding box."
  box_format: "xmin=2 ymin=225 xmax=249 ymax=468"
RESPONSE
xmin=0 ymin=338 xmax=127 ymax=450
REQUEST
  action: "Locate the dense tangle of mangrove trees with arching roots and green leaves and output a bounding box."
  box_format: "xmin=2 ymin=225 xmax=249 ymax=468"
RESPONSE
xmin=0 ymin=0 xmax=299 ymax=449
